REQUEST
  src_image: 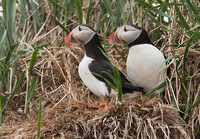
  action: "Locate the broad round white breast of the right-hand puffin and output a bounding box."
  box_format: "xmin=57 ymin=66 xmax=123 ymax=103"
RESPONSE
xmin=126 ymin=44 xmax=166 ymax=93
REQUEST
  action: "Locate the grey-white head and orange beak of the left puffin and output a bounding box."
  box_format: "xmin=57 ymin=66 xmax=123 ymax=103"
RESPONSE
xmin=65 ymin=24 xmax=96 ymax=46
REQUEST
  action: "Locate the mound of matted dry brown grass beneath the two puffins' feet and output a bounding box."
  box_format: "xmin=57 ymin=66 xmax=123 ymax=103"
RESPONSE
xmin=0 ymin=98 xmax=189 ymax=138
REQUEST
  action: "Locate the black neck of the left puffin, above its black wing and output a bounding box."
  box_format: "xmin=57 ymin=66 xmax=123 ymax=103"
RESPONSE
xmin=84 ymin=34 xmax=106 ymax=60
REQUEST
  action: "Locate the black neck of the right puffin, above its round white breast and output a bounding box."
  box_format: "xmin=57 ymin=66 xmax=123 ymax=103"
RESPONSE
xmin=128 ymin=29 xmax=153 ymax=48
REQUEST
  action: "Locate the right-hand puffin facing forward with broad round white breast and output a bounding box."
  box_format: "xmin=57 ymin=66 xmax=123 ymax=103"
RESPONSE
xmin=108 ymin=24 xmax=168 ymax=98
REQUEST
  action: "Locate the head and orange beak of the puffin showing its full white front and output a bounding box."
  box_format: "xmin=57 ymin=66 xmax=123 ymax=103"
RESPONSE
xmin=108 ymin=25 xmax=144 ymax=45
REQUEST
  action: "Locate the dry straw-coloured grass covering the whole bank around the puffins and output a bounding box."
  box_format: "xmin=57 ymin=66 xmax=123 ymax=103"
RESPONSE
xmin=0 ymin=0 xmax=200 ymax=138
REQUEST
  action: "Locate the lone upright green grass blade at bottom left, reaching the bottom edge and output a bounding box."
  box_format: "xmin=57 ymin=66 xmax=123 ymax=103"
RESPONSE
xmin=37 ymin=92 xmax=42 ymax=139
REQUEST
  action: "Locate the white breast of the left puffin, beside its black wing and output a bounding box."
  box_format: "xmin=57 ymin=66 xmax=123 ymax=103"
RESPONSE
xmin=78 ymin=55 xmax=116 ymax=97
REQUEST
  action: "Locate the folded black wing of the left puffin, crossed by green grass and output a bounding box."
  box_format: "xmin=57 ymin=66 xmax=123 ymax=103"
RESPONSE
xmin=89 ymin=61 xmax=143 ymax=93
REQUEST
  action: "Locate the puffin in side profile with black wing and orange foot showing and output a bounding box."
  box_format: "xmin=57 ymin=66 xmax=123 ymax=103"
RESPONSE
xmin=65 ymin=24 xmax=144 ymax=108
